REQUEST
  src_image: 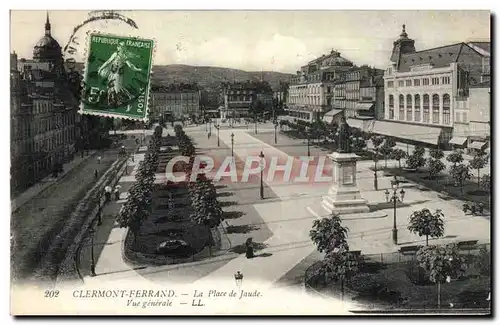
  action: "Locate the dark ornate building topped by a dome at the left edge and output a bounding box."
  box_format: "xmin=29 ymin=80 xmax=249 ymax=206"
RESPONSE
xmin=11 ymin=15 xmax=80 ymax=194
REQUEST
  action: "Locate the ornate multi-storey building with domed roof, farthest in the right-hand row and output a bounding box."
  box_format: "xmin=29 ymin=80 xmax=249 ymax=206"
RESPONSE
xmin=287 ymin=50 xmax=353 ymax=122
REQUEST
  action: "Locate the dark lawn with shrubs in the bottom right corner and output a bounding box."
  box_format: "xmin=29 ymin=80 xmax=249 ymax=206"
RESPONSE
xmin=314 ymin=249 xmax=491 ymax=309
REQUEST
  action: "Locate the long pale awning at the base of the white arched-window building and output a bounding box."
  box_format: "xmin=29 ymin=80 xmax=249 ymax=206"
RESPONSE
xmin=373 ymin=121 xmax=441 ymax=145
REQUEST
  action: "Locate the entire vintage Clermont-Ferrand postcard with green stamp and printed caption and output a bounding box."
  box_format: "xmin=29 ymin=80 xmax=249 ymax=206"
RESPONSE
xmin=10 ymin=10 xmax=492 ymax=317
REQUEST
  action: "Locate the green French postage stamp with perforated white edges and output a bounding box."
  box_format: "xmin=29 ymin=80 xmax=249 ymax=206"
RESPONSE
xmin=80 ymin=33 xmax=154 ymax=120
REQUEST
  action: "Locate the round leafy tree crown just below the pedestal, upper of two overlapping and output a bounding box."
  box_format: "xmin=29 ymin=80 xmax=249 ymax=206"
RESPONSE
xmin=309 ymin=213 xmax=349 ymax=253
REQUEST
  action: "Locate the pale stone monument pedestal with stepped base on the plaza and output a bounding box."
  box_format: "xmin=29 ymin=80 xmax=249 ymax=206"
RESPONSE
xmin=321 ymin=152 xmax=370 ymax=214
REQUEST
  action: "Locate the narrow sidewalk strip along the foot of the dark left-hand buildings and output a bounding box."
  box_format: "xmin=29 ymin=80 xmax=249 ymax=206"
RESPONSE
xmin=10 ymin=151 xmax=96 ymax=212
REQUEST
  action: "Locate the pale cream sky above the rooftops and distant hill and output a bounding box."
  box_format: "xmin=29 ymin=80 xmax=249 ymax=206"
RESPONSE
xmin=10 ymin=10 xmax=490 ymax=73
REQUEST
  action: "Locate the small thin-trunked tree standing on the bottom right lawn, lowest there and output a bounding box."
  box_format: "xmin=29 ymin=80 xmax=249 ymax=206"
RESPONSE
xmin=417 ymin=244 xmax=463 ymax=308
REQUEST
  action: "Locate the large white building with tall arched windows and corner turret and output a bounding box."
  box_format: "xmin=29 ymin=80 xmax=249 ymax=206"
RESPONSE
xmin=371 ymin=25 xmax=485 ymax=146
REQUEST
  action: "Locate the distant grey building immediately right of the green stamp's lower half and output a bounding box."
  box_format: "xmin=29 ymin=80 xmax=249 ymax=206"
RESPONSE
xmin=150 ymin=84 xmax=201 ymax=119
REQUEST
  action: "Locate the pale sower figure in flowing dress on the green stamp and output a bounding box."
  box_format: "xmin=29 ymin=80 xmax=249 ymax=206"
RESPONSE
xmin=98 ymin=42 xmax=142 ymax=106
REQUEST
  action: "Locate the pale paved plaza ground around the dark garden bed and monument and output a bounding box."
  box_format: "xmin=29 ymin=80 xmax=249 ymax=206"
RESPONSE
xmin=76 ymin=126 xmax=490 ymax=285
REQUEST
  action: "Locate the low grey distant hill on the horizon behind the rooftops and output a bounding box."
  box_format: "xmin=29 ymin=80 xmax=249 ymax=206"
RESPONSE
xmin=67 ymin=63 xmax=293 ymax=89
